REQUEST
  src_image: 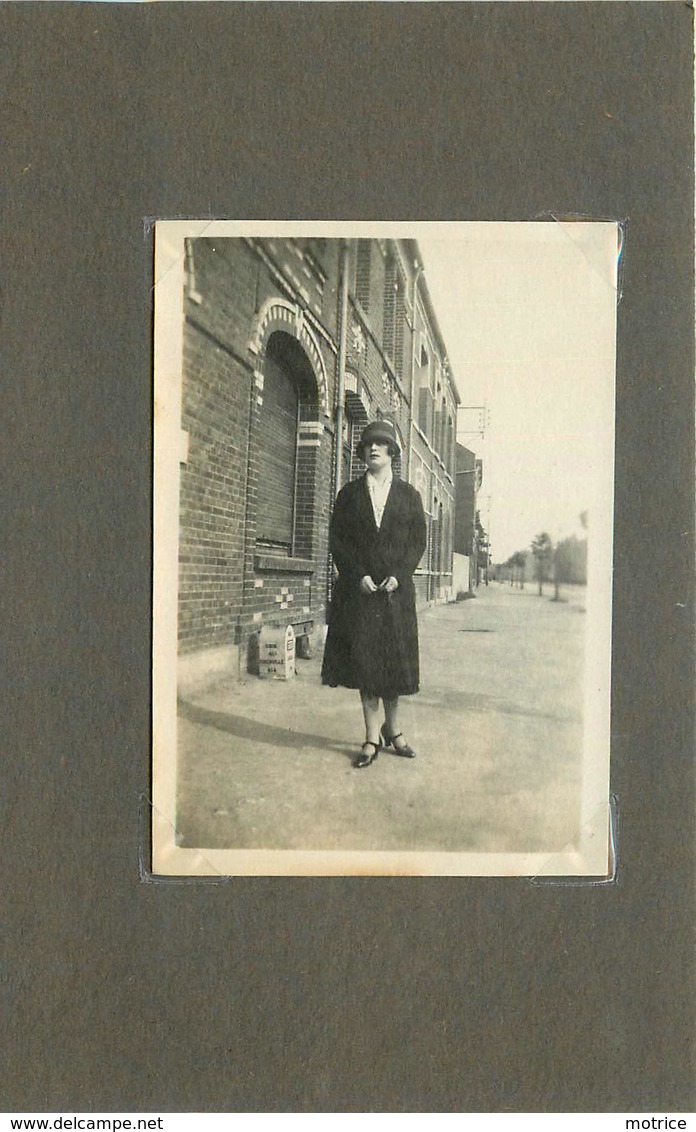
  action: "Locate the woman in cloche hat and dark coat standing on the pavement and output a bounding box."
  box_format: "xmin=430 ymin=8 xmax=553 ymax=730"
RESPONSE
xmin=321 ymin=420 xmax=427 ymax=769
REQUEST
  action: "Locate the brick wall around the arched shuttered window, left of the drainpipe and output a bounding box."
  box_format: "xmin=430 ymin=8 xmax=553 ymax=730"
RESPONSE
xmin=179 ymin=239 xmax=337 ymax=654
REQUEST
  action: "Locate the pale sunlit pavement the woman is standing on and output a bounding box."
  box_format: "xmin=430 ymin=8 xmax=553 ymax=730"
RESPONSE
xmin=177 ymin=583 xmax=585 ymax=852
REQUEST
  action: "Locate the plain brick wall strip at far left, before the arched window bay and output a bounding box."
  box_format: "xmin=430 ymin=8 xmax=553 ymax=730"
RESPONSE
xmin=179 ymin=240 xmax=256 ymax=652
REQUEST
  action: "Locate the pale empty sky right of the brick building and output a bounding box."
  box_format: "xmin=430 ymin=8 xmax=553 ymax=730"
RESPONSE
xmin=418 ymin=223 xmax=617 ymax=561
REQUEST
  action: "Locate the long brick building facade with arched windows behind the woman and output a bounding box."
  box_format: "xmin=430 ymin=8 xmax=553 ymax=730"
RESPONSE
xmin=179 ymin=237 xmax=458 ymax=678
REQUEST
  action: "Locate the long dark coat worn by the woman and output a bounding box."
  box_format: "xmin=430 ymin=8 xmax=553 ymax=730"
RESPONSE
xmin=321 ymin=475 xmax=427 ymax=700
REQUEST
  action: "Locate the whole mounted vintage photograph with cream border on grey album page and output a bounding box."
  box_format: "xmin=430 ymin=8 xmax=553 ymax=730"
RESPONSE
xmin=153 ymin=216 xmax=621 ymax=877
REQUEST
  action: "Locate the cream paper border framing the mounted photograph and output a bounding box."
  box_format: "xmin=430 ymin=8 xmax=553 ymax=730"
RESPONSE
xmin=152 ymin=220 xmax=619 ymax=878
